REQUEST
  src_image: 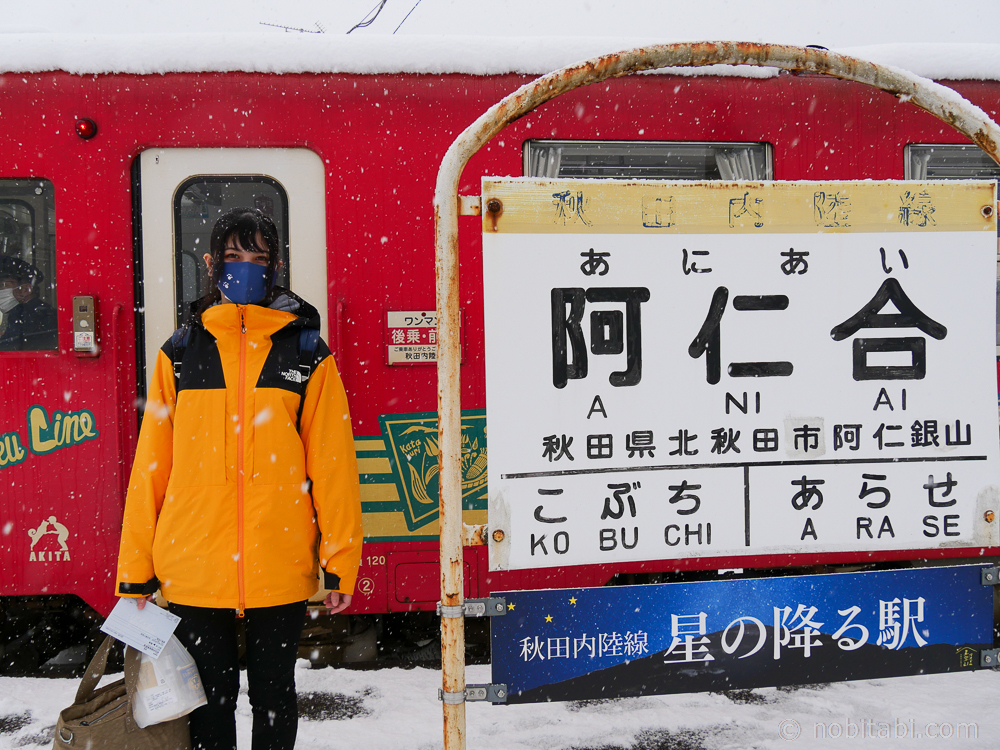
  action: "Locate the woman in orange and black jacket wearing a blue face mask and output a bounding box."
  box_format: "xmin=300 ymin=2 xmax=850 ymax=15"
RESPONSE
xmin=116 ymin=208 xmax=362 ymax=750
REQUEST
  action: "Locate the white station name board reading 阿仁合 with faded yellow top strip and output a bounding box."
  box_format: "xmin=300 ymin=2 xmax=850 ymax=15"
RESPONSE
xmin=483 ymin=179 xmax=1000 ymax=570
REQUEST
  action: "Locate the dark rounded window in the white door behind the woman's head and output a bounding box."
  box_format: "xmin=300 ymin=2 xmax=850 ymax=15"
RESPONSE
xmin=174 ymin=175 xmax=290 ymax=326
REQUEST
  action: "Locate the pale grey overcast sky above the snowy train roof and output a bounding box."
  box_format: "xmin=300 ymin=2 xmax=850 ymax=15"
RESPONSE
xmin=0 ymin=0 xmax=997 ymax=47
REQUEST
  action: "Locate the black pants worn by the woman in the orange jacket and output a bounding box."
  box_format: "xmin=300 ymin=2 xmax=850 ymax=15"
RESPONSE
xmin=170 ymin=602 xmax=306 ymax=750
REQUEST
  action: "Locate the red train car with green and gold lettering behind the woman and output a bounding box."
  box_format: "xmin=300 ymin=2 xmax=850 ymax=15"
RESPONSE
xmin=0 ymin=39 xmax=1000 ymax=664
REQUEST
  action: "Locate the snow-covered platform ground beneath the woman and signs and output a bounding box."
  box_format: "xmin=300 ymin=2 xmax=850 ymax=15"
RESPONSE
xmin=0 ymin=661 xmax=1000 ymax=750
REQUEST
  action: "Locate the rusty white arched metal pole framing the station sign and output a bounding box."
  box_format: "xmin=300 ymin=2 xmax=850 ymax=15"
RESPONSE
xmin=434 ymin=42 xmax=1000 ymax=750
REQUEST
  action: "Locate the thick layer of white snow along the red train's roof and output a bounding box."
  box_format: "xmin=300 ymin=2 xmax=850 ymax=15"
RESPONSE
xmin=0 ymin=32 xmax=1000 ymax=80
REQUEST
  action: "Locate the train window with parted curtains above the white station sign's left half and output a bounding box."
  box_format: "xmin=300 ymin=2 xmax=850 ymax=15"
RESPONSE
xmin=524 ymin=141 xmax=772 ymax=180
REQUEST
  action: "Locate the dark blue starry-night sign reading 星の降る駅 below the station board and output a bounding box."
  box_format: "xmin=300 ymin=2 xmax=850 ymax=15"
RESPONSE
xmin=491 ymin=565 xmax=993 ymax=703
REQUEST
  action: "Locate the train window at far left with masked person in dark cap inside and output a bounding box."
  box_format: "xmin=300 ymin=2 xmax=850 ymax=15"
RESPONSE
xmin=0 ymin=179 xmax=59 ymax=352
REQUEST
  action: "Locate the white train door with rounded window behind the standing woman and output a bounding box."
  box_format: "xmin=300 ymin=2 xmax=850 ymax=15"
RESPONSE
xmin=133 ymin=148 xmax=329 ymax=394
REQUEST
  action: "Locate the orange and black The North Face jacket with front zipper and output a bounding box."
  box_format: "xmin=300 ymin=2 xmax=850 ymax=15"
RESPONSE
xmin=116 ymin=294 xmax=362 ymax=611
